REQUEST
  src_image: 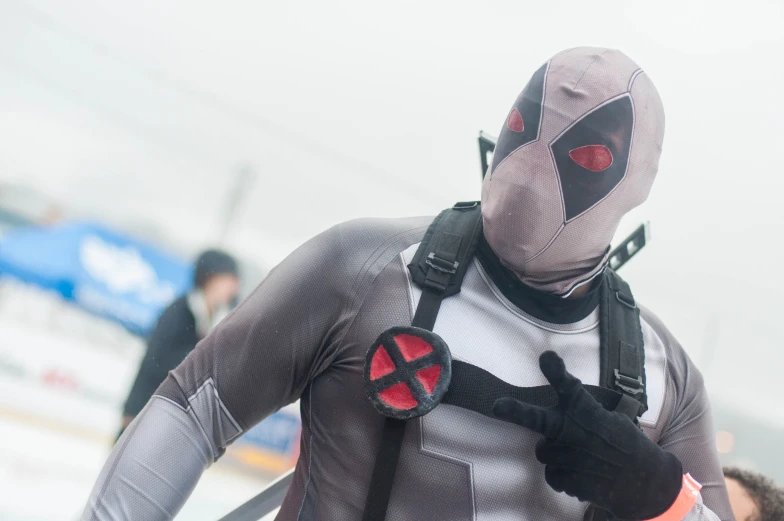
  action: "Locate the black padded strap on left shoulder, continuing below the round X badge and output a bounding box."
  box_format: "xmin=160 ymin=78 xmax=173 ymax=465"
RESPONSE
xmin=362 ymin=202 xmax=482 ymax=521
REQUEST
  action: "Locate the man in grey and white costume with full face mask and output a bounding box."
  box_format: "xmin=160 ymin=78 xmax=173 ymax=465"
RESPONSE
xmin=82 ymin=48 xmax=732 ymax=521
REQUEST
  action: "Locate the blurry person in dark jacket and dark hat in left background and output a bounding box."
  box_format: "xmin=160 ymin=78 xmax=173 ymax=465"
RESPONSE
xmin=117 ymin=250 xmax=239 ymax=439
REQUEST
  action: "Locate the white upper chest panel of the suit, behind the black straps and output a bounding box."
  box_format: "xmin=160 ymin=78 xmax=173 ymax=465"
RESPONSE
xmin=402 ymin=244 xmax=666 ymax=426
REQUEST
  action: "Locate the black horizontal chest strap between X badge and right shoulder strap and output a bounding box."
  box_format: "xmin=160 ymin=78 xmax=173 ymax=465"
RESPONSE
xmin=441 ymin=360 xmax=622 ymax=418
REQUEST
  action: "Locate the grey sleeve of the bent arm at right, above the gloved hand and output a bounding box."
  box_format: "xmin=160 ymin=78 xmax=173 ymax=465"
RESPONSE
xmin=643 ymin=310 xmax=734 ymax=521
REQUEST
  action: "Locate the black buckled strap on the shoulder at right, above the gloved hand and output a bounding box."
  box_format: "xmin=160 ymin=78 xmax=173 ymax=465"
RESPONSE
xmin=599 ymin=268 xmax=648 ymax=422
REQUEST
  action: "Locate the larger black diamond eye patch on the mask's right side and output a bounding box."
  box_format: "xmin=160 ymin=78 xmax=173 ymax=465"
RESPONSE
xmin=550 ymin=95 xmax=634 ymax=222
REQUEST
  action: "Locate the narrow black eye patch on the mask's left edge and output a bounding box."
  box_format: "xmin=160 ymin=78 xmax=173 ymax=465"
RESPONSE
xmin=490 ymin=63 xmax=549 ymax=174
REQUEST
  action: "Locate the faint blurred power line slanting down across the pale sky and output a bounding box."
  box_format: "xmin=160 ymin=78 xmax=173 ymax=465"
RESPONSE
xmin=9 ymin=4 xmax=443 ymax=198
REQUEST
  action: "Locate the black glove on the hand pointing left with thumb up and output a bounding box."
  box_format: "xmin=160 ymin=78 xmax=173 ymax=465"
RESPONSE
xmin=493 ymin=351 xmax=683 ymax=520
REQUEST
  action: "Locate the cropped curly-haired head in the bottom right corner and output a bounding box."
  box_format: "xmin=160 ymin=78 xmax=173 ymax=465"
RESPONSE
xmin=724 ymin=468 xmax=784 ymax=521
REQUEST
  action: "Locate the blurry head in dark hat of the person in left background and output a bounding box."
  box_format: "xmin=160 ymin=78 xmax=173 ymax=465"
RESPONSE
xmin=193 ymin=250 xmax=240 ymax=310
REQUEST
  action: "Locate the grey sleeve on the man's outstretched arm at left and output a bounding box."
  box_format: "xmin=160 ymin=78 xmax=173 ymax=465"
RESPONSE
xmin=82 ymin=219 xmax=429 ymax=521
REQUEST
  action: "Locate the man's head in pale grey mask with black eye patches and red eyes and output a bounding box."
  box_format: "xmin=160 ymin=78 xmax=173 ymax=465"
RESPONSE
xmin=482 ymin=47 xmax=664 ymax=296
